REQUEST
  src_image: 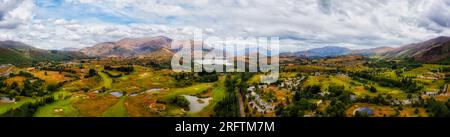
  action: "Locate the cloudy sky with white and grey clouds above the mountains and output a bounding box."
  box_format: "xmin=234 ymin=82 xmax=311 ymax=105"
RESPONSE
xmin=0 ymin=0 xmax=450 ymax=51
